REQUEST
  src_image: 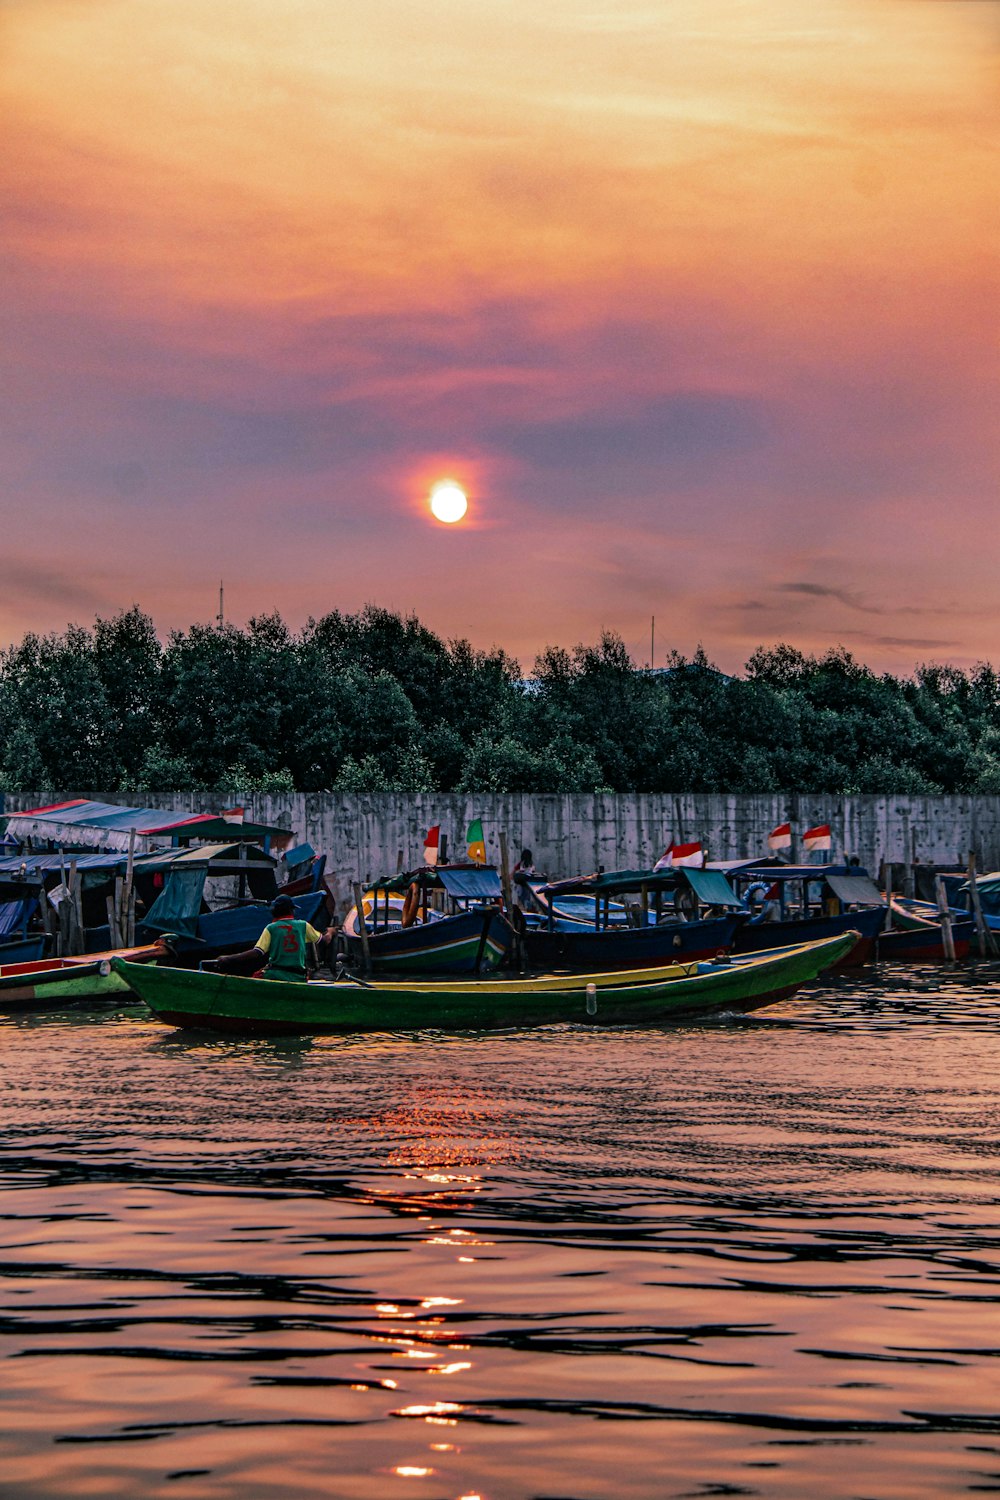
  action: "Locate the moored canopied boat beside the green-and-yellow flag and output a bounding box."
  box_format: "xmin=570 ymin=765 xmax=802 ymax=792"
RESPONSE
xmin=342 ymin=864 xmax=516 ymax=975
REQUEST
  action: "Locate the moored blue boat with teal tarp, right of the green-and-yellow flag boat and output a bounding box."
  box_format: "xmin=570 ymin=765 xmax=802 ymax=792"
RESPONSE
xmin=523 ymin=866 xmax=743 ymax=974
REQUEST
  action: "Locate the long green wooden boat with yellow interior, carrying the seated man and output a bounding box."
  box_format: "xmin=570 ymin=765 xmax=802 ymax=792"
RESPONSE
xmin=112 ymin=933 xmax=859 ymax=1035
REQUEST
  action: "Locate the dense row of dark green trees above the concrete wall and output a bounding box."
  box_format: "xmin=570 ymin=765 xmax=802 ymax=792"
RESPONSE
xmin=0 ymin=606 xmax=1000 ymax=794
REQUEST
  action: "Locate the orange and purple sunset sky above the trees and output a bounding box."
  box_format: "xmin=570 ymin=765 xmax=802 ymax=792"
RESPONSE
xmin=0 ymin=0 xmax=1000 ymax=674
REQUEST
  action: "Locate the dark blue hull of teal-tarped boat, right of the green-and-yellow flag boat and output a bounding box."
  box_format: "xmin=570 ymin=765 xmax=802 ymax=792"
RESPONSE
xmin=525 ymin=917 xmax=743 ymax=974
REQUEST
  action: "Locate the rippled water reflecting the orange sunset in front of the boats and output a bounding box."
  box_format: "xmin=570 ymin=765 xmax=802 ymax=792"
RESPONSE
xmin=0 ymin=965 xmax=1000 ymax=1500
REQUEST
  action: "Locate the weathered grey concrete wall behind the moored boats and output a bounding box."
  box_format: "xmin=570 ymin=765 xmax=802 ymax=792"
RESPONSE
xmin=6 ymin=792 xmax=1000 ymax=899
